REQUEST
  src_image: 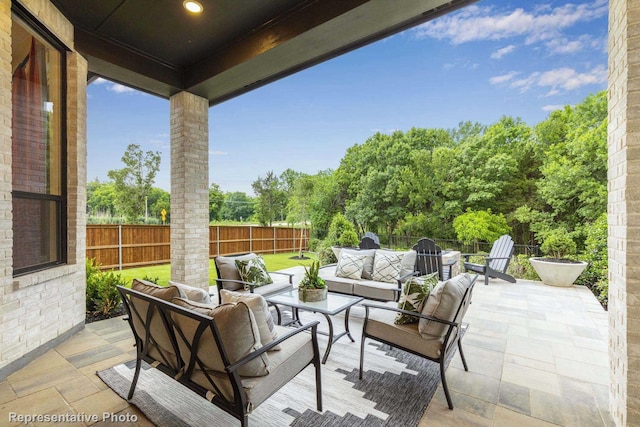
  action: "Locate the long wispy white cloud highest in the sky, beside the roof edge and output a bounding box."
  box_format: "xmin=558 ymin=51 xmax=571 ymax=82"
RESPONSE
xmin=414 ymin=0 xmax=608 ymax=44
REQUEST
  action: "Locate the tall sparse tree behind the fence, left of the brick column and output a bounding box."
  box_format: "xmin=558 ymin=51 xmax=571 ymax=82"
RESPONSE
xmin=107 ymin=144 xmax=160 ymax=221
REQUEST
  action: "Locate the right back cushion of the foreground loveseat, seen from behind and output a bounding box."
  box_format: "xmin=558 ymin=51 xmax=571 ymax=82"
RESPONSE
xmin=172 ymin=298 xmax=270 ymax=378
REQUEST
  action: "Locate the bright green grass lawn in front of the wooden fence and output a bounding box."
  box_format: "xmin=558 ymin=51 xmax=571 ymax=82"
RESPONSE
xmin=114 ymin=252 xmax=316 ymax=286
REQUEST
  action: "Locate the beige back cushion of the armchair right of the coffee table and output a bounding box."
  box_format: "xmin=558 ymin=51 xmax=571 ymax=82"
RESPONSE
xmin=418 ymin=273 xmax=471 ymax=340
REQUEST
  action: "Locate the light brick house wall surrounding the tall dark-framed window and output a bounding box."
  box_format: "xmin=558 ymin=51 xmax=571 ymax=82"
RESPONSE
xmin=0 ymin=0 xmax=87 ymax=379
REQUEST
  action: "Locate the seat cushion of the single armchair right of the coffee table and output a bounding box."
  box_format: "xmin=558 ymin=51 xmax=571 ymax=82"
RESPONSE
xmin=367 ymin=303 xmax=442 ymax=359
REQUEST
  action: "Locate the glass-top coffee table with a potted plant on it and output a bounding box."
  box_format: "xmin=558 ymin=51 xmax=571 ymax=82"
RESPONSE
xmin=265 ymin=288 xmax=364 ymax=363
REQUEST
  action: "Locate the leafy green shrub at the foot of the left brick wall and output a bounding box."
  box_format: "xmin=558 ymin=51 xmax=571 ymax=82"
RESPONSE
xmin=86 ymin=258 xmax=126 ymax=316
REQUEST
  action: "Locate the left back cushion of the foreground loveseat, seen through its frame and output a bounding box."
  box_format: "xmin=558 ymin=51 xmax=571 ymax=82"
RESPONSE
xmin=130 ymin=279 xmax=180 ymax=370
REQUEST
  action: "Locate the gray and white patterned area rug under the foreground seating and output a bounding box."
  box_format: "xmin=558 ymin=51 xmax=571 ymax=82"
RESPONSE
xmin=98 ymin=312 xmax=462 ymax=427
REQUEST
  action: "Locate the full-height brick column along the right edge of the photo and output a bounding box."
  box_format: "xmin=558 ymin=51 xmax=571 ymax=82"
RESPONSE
xmin=608 ymin=0 xmax=640 ymax=426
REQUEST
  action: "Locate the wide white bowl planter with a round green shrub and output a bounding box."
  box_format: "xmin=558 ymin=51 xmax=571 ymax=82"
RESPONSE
xmin=529 ymin=229 xmax=588 ymax=287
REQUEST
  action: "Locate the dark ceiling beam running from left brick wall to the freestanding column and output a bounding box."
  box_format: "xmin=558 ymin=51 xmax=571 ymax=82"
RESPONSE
xmin=74 ymin=27 xmax=185 ymax=97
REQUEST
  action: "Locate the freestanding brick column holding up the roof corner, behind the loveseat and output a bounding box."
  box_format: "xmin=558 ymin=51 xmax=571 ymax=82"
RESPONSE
xmin=170 ymin=92 xmax=209 ymax=289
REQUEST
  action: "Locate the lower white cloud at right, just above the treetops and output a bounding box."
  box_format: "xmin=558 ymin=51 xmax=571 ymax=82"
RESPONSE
xmin=505 ymin=65 xmax=607 ymax=96
